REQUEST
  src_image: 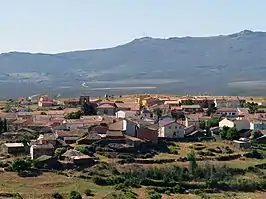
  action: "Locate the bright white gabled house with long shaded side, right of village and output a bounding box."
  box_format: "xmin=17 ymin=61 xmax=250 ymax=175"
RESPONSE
xmin=219 ymin=118 xmax=250 ymax=131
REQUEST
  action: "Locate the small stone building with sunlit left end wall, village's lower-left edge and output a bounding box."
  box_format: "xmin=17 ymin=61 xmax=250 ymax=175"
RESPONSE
xmin=30 ymin=143 xmax=54 ymax=159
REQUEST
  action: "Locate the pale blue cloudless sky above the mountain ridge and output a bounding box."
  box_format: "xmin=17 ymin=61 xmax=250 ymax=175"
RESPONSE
xmin=0 ymin=0 xmax=266 ymax=53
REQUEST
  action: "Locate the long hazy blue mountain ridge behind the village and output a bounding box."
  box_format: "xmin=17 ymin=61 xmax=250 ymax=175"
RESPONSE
xmin=0 ymin=30 xmax=266 ymax=97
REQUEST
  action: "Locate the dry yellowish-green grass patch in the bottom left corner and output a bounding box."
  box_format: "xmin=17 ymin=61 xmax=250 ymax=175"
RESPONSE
xmin=0 ymin=172 xmax=113 ymax=199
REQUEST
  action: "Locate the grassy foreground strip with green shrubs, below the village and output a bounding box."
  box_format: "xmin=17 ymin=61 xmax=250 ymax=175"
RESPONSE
xmin=0 ymin=142 xmax=266 ymax=199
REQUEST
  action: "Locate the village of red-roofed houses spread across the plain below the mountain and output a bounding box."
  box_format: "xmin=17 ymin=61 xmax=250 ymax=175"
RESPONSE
xmin=0 ymin=94 xmax=266 ymax=198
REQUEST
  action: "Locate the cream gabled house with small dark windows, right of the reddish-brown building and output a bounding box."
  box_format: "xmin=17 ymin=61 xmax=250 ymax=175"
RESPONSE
xmin=159 ymin=120 xmax=185 ymax=138
